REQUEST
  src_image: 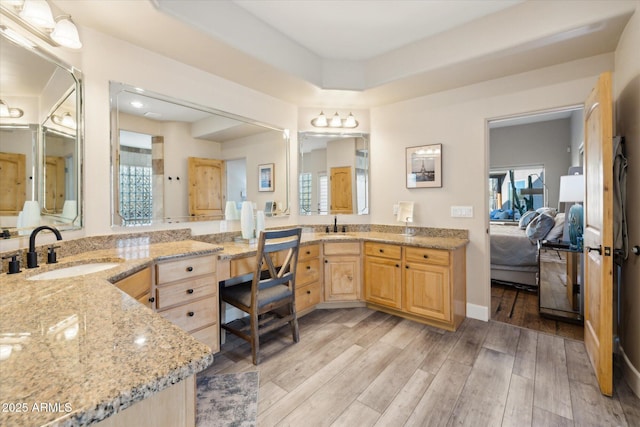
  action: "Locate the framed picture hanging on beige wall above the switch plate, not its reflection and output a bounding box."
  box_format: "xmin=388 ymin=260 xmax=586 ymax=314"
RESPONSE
xmin=406 ymin=144 xmax=442 ymax=188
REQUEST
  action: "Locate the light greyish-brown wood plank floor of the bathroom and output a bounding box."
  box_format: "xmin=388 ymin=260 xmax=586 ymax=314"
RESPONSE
xmin=201 ymin=308 xmax=640 ymax=427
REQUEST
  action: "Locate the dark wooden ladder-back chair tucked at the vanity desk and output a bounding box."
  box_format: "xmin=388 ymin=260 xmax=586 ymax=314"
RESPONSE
xmin=220 ymin=228 xmax=302 ymax=365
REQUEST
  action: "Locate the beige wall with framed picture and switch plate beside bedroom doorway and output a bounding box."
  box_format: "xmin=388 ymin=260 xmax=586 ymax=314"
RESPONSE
xmin=371 ymin=55 xmax=613 ymax=319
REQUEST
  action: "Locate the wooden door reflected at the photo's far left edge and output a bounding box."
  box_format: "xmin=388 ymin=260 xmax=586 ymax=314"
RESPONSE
xmin=0 ymin=153 xmax=27 ymax=215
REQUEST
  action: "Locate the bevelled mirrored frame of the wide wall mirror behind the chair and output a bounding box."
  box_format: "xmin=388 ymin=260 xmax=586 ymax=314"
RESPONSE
xmin=109 ymin=81 xmax=291 ymax=228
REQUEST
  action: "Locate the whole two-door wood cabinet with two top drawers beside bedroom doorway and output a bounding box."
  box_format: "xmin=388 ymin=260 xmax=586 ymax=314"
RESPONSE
xmin=364 ymin=242 xmax=466 ymax=330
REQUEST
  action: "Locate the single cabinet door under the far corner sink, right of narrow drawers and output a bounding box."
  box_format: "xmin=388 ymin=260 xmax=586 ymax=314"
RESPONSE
xmin=324 ymin=256 xmax=360 ymax=301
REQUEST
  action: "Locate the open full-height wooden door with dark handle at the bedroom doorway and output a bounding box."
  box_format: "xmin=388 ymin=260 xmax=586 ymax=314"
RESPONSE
xmin=584 ymin=73 xmax=613 ymax=396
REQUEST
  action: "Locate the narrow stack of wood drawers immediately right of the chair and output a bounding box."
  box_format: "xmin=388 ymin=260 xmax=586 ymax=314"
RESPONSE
xmin=296 ymin=244 xmax=323 ymax=315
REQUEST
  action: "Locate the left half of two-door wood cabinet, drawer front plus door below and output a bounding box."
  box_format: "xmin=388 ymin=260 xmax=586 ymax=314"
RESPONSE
xmin=364 ymin=242 xmax=402 ymax=309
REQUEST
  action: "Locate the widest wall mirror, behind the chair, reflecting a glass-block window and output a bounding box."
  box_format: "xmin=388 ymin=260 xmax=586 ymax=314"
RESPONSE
xmin=110 ymin=82 xmax=289 ymax=226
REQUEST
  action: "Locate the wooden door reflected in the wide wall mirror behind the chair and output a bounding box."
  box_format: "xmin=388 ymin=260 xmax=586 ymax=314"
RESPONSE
xmin=188 ymin=157 xmax=226 ymax=216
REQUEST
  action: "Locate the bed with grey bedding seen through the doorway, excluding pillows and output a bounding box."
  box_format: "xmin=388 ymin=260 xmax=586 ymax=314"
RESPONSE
xmin=489 ymin=222 xmax=538 ymax=288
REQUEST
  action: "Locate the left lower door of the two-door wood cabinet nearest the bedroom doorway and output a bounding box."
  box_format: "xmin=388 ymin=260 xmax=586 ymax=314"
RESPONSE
xmin=364 ymin=257 xmax=402 ymax=308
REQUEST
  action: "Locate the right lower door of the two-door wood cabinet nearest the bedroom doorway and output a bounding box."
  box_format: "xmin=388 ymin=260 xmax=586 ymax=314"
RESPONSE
xmin=404 ymin=263 xmax=451 ymax=322
